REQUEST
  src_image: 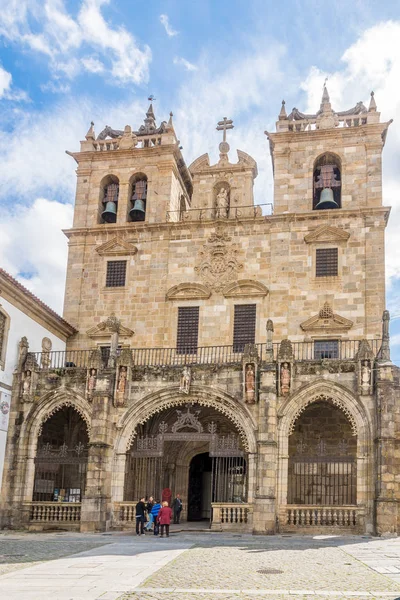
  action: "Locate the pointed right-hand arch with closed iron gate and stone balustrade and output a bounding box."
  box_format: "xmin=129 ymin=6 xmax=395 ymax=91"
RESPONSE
xmin=278 ymin=382 xmax=373 ymax=533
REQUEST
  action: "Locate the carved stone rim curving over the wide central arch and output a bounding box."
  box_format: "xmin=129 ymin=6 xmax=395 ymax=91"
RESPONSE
xmin=115 ymin=385 xmax=257 ymax=454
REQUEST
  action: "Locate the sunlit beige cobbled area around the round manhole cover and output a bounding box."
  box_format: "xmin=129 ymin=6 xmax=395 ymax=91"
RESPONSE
xmin=127 ymin=537 xmax=400 ymax=600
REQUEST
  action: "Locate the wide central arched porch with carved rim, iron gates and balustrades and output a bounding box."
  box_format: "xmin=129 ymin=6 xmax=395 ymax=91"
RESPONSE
xmin=113 ymin=386 xmax=255 ymax=529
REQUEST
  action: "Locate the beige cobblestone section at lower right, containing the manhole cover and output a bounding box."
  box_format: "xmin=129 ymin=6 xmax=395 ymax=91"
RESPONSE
xmin=121 ymin=536 xmax=400 ymax=600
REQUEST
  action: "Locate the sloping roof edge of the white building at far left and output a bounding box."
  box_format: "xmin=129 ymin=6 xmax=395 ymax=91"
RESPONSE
xmin=0 ymin=269 xmax=77 ymax=341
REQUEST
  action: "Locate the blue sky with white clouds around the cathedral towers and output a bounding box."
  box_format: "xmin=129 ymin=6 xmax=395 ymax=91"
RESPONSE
xmin=0 ymin=0 xmax=400 ymax=356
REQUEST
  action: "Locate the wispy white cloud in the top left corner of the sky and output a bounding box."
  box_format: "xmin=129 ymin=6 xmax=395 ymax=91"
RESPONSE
xmin=0 ymin=0 xmax=151 ymax=85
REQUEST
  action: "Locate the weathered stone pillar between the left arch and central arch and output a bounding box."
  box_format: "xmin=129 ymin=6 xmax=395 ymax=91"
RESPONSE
xmin=81 ymin=369 xmax=115 ymax=532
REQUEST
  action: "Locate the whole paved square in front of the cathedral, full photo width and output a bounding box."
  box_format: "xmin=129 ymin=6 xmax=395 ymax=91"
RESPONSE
xmin=0 ymin=532 xmax=400 ymax=600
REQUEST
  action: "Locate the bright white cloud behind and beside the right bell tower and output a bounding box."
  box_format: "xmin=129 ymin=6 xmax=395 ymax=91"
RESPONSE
xmin=299 ymin=21 xmax=400 ymax=289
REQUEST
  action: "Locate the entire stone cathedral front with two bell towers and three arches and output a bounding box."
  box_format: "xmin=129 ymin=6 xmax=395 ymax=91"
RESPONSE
xmin=1 ymin=88 xmax=400 ymax=534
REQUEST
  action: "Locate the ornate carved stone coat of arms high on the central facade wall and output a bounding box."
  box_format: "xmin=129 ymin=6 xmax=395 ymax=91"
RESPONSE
xmin=195 ymin=230 xmax=243 ymax=292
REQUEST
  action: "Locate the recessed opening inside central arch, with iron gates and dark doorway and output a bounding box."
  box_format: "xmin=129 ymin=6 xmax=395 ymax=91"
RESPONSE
xmin=123 ymin=403 xmax=248 ymax=520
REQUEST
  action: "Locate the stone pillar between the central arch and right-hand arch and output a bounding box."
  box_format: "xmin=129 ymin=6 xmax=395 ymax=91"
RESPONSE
xmin=253 ymin=362 xmax=277 ymax=534
